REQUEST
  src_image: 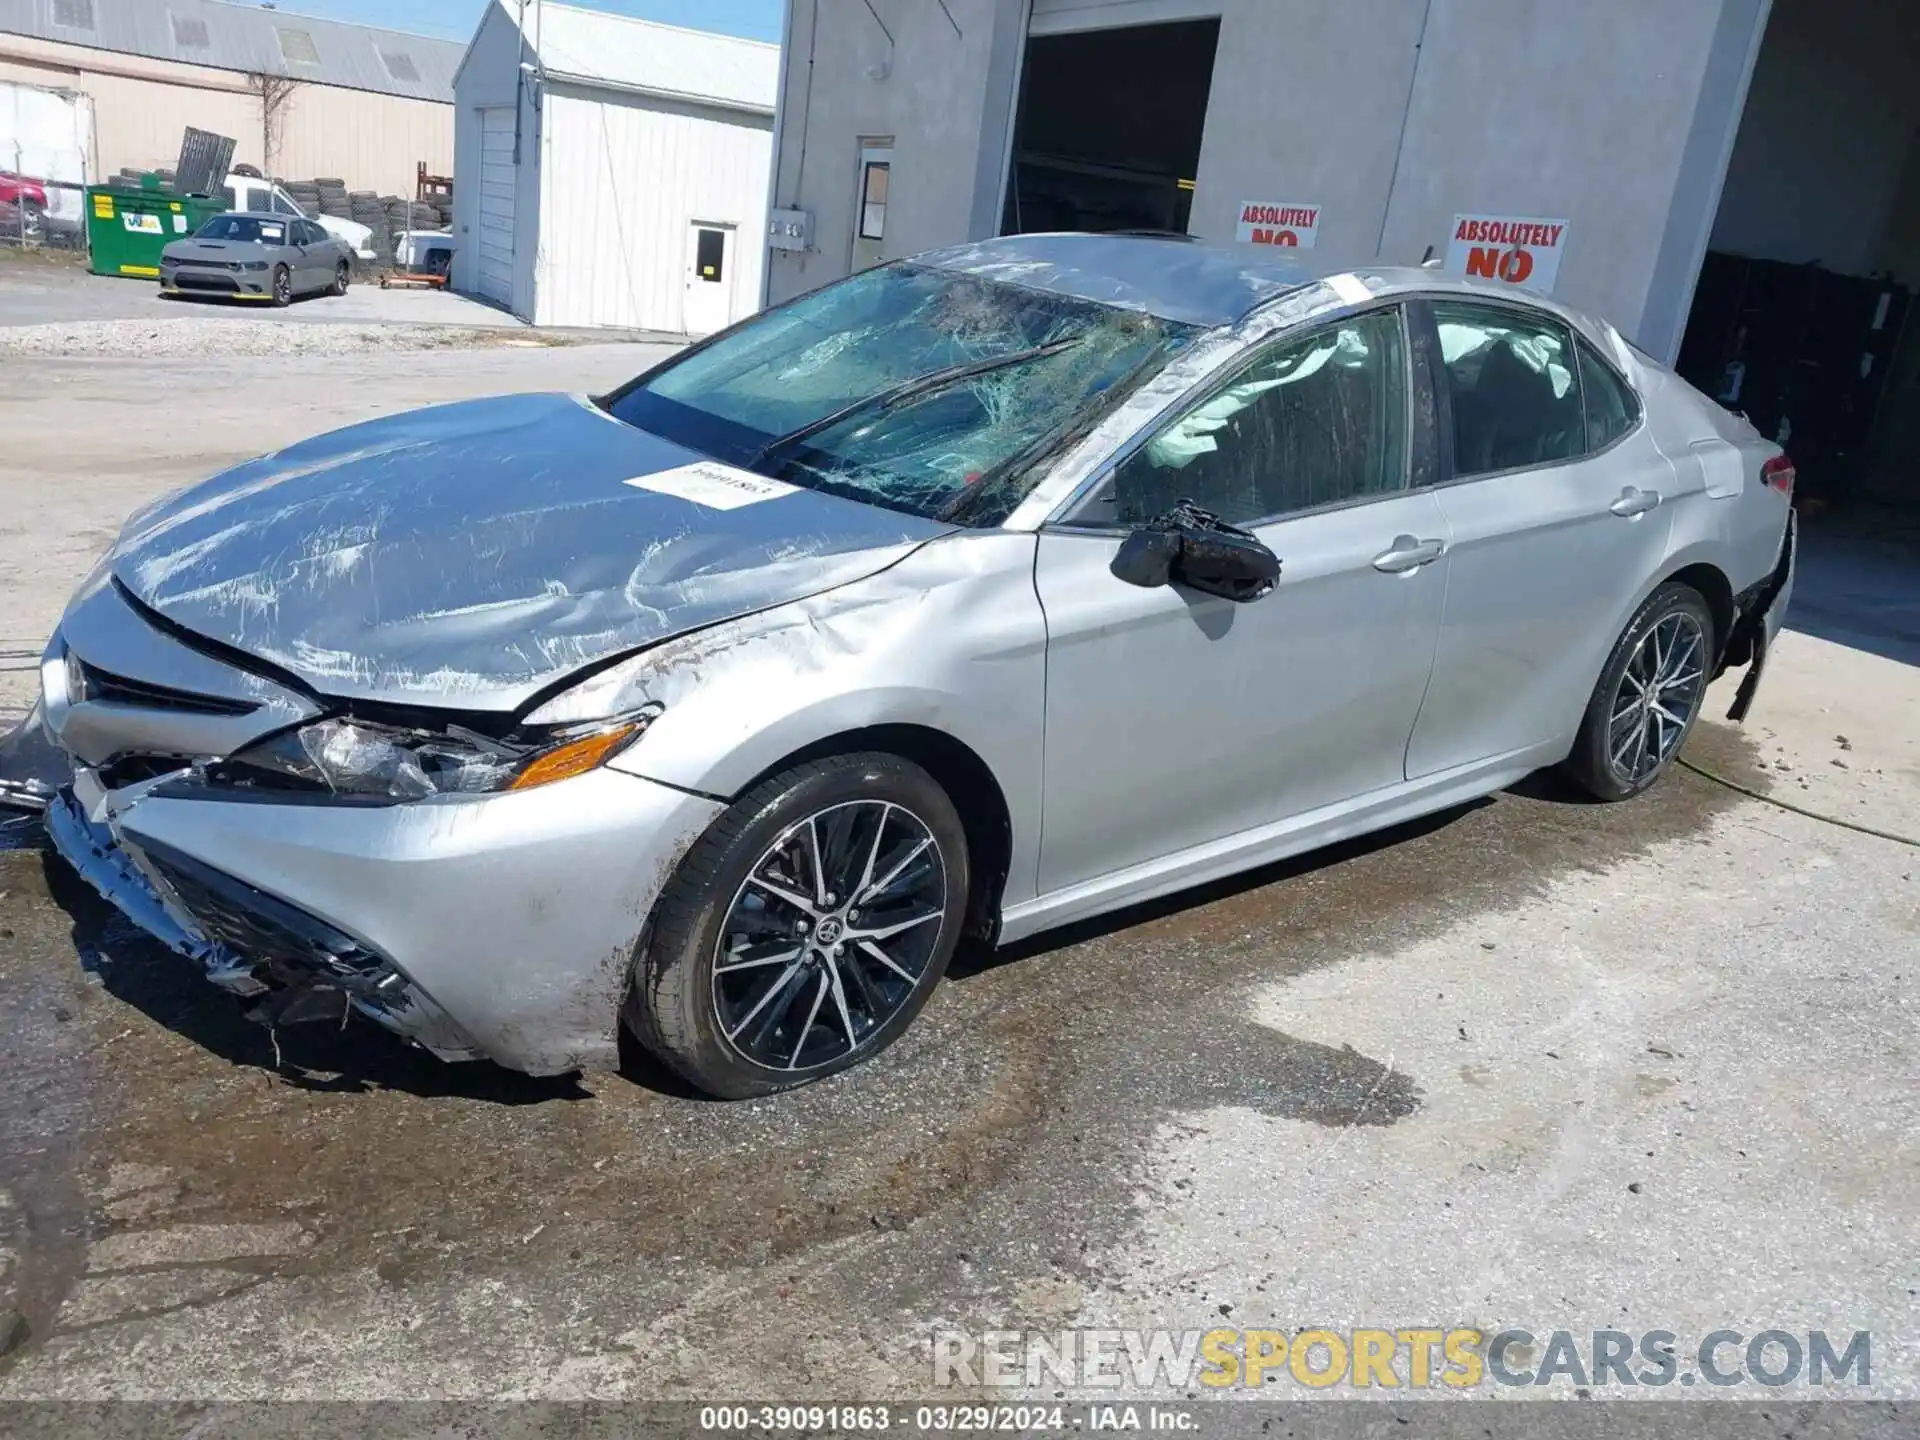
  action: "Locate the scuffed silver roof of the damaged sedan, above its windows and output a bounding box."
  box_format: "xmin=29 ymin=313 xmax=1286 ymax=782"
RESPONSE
xmin=912 ymin=234 xmax=1601 ymax=334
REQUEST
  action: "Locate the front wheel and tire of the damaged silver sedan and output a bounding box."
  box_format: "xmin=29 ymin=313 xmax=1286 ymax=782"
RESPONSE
xmin=626 ymin=753 xmax=970 ymax=1100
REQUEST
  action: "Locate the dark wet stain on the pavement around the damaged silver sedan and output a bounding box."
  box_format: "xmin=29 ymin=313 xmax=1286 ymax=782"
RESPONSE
xmin=0 ymin=726 xmax=1751 ymax=1374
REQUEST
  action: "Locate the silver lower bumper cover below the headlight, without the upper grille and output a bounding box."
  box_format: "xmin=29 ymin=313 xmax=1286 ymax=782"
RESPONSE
xmin=46 ymin=766 xmax=724 ymax=1075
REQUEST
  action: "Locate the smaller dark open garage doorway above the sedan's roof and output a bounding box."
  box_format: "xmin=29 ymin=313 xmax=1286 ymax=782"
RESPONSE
xmin=1000 ymin=19 xmax=1219 ymax=234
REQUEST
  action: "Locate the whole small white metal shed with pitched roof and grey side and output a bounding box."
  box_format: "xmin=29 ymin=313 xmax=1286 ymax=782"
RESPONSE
xmin=453 ymin=0 xmax=780 ymax=334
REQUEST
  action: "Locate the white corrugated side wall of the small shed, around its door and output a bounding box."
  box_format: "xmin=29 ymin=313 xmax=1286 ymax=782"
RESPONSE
xmin=534 ymin=86 xmax=774 ymax=332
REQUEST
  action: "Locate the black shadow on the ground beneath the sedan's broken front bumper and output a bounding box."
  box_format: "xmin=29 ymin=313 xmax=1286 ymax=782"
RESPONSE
xmin=42 ymin=851 xmax=593 ymax=1106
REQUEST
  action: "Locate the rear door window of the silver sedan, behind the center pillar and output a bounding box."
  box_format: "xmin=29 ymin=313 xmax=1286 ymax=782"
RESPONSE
xmin=1434 ymin=300 xmax=1586 ymax=476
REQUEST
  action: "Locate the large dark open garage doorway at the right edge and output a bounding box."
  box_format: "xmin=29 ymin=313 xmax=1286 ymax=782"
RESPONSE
xmin=1676 ymin=0 xmax=1920 ymax=511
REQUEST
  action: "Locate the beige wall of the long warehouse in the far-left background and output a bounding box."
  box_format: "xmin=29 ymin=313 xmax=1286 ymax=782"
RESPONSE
xmin=0 ymin=35 xmax=453 ymax=196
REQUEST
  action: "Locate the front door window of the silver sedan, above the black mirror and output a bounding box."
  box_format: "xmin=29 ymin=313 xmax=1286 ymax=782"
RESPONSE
xmin=1112 ymin=309 xmax=1407 ymax=524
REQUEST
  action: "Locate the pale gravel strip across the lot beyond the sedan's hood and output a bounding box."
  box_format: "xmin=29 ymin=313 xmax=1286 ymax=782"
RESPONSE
xmin=0 ymin=315 xmax=574 ymax=359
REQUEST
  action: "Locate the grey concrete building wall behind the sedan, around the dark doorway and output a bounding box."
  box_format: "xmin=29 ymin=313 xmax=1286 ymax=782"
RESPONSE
xmin=770 ymin=0 xmax=1766 ymax=353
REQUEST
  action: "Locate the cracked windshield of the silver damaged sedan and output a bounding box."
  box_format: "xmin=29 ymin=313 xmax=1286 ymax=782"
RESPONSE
xmin=607 ymin=265 xmax=1196 ymax=524
